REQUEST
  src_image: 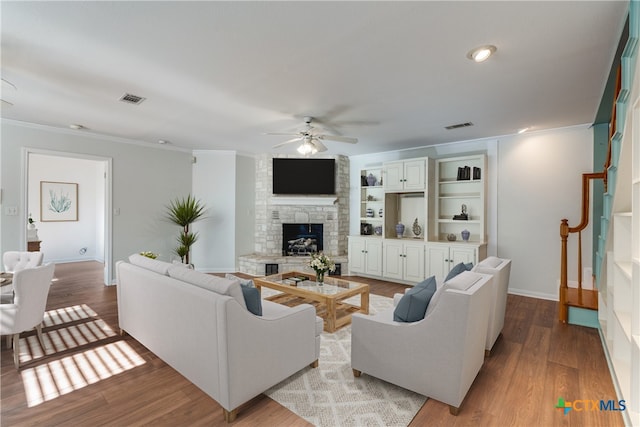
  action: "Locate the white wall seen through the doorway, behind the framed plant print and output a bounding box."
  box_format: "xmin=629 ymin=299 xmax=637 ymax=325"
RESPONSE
xmin=27 ymin=153 xmax=105 ymax=262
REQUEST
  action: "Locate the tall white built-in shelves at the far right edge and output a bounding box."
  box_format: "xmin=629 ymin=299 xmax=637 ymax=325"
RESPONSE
xmin=598 ymin=65 xmax=640 ymax=426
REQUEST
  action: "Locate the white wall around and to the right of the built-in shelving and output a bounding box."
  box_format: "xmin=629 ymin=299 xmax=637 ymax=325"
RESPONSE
xmin=350 ymin=126 xmax=599 ymax=300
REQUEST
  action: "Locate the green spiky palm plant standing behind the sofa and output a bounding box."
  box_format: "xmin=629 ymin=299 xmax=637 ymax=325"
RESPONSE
xmin=167 ymin=194 xmax=205 ymax=264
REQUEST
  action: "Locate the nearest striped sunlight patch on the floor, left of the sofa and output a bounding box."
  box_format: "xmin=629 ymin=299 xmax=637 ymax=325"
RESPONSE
xmin=21 ymin=341 xmax=146 ymax=408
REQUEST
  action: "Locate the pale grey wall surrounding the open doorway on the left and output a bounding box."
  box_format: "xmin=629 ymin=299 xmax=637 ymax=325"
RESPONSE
xmin=0 ymin=119 xmax=192 ymax=282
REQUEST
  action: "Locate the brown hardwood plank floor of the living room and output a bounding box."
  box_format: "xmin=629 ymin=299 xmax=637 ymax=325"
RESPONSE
xmin=0 ymin=262 xmax=623 ymax=427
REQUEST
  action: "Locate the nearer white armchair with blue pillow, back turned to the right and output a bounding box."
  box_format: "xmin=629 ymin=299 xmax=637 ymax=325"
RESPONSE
xmin=351 ymin=271 xmax=493 ymax=415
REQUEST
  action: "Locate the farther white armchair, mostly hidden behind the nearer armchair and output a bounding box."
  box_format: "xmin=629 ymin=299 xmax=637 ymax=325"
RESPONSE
xmin=471 ymin=256 xmax=511 ymax=356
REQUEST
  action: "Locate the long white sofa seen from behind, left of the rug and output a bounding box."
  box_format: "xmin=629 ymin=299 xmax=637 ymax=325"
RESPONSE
xmin=116 ymin=254 xmax=322 ymax=422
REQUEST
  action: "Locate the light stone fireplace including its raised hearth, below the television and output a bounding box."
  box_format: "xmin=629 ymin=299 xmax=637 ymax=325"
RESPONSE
xmin=238 ymin=154 xmax=349 ymax=276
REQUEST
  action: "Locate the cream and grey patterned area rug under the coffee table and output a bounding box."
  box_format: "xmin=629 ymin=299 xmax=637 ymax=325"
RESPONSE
xmin=263 ymin=288 xmax=427 ymax=427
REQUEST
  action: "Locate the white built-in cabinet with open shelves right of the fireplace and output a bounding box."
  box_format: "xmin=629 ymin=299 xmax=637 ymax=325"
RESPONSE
xmin=349 ymin=154 xmax=487 ymax=284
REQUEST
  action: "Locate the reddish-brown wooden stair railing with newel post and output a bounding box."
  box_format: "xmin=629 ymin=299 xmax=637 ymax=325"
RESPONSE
xmin=558 ymin=67 xmax=622 ymax=323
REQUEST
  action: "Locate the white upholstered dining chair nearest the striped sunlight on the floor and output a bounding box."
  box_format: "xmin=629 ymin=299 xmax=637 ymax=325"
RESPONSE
xmin=0 ymin=264 xmax=55 ymax=368
